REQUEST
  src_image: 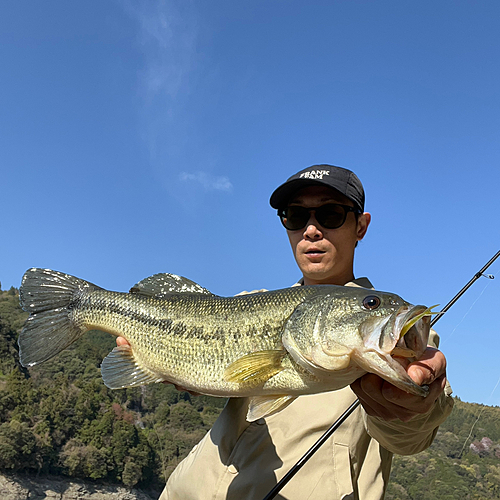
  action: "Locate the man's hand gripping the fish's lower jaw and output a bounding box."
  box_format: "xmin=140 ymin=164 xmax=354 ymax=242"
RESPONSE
xmin=351 ymin=347 xmax=446 ymax=422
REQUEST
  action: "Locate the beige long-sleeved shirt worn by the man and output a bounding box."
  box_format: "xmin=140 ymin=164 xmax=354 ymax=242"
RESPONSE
xmin=160 ymin=278 xmax=453 ymax=500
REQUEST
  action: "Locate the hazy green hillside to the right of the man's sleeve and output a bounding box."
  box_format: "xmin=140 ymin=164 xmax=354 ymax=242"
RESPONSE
xmin=386 ymin=398 xmax=500 ymax=500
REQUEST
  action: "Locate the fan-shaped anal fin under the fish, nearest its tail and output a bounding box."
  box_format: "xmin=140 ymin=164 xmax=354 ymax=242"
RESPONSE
xmin=101 ymin=345 xmax=164 ymax=389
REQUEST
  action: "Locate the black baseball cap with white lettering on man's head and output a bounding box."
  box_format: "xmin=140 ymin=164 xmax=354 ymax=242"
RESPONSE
xmin=269 ymin=165 xmax=365 ymax=212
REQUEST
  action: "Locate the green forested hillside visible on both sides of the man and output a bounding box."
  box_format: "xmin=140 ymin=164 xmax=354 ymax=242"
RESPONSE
xmin=0 ymin=288 xmax=500 ymax=500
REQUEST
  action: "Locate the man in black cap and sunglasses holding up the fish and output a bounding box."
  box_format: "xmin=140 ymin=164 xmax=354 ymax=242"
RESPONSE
xmin=129 ymin=165 xmax=452 ymax=500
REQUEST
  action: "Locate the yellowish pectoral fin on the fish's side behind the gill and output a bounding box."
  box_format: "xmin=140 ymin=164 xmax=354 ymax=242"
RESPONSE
xmin=224 ymin=349 xmax=286 ymax=385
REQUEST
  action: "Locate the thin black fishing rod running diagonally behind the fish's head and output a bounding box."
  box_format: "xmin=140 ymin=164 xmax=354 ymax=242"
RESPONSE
xmin=263 ymin=250 xmax=500 ymax=500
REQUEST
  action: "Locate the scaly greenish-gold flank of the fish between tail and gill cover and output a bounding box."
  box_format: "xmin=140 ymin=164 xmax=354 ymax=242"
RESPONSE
xmin=67 ymin=288 xmax=304 ymax=393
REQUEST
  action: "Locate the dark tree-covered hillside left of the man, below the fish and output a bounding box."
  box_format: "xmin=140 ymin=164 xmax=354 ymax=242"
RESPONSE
xmin=0 ymin=288 xmax=225 ymax=490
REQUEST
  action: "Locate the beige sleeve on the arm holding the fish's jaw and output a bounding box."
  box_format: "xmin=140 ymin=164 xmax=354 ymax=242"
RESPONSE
xmin=364 ymin=330 xmax=453 ymax=455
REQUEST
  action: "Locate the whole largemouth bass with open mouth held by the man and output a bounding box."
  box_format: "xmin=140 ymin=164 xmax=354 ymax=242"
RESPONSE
xmin=19 ymin=268 xmax=432 ymax=421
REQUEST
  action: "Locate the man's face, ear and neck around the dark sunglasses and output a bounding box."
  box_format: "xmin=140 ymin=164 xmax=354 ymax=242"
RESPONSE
xmin=287 ymin=186 xmax=371 ymax=285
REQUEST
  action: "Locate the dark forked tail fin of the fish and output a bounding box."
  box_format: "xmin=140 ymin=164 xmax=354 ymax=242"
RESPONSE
xmin=18 ymin=268 xmax=99 ymax=366
